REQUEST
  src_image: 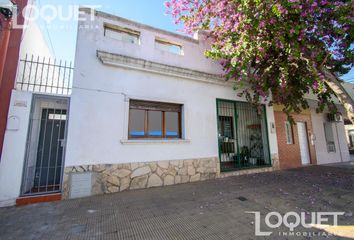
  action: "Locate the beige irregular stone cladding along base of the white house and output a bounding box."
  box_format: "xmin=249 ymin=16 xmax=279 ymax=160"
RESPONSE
xmin=63 ymin=157 xmax=220 ymax=199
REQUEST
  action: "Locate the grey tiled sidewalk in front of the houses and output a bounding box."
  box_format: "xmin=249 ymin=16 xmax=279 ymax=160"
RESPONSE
xmin=0 ymin=166 xmax=354 ymax=240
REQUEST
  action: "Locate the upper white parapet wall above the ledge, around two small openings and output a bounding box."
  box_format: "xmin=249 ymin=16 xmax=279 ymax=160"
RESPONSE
xmin=75 ymin=9 xmax=223 ymax=74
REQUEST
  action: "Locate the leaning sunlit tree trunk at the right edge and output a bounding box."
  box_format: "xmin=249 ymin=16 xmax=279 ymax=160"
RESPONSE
xmin=320 ymin=67 xmax=354 ymax=124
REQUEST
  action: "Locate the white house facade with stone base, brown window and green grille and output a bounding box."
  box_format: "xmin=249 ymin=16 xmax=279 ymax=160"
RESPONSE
xmin=63 ymin=10 xmax=277 ymax=197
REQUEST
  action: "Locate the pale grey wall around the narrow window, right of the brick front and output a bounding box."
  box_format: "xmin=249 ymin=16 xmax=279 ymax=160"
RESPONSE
xmin=311 ymin=110 xmax=350 ymax=165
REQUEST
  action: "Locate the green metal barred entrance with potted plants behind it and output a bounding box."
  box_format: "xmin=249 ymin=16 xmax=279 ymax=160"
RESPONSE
xmin=216 ymin=99 xmax=271 ymax=171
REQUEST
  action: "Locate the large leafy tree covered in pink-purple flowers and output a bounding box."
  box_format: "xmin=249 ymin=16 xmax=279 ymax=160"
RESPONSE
xmin=165 ymin=0 xmax=354 ymax=121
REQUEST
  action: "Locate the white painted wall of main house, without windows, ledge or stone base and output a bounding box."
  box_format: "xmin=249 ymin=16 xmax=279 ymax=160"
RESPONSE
xmin=65 ymin=11 xmax=277 ymax=166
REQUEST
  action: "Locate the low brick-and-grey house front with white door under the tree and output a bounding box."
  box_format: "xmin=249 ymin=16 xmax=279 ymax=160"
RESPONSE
xmin=274 ymin=88 xmax=350 ymax=169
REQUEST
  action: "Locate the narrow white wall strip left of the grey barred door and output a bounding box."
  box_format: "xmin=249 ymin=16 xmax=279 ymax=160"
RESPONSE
xmin=0 ymin=90 xmax=32 ymax=207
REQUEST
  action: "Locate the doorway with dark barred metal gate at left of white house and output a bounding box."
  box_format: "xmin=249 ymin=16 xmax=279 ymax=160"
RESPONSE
xmin=22 ymin=96 xmax=68 ymax=195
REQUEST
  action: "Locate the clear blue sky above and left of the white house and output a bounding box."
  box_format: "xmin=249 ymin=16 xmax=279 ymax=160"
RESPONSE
xmin=36 ymin=0 xmax=354 ymax=82
